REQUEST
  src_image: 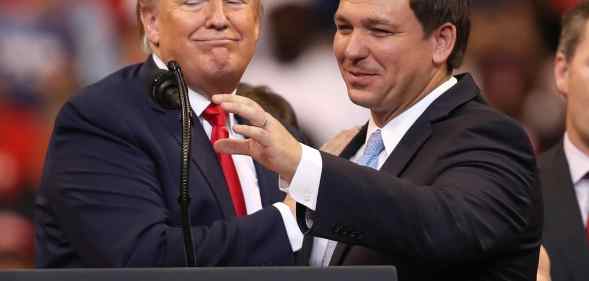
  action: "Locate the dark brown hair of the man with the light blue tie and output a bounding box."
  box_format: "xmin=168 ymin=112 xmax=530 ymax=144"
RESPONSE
xmin=409 ymin=0 xmax=470 ymax=71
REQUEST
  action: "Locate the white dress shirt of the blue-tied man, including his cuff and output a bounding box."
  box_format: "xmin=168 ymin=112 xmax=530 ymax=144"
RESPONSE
xmin=288 ymin=77 xmax=458 ymax=266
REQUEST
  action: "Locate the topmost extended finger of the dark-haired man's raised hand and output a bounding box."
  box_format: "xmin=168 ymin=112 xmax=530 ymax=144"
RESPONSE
xmin=212 ymin=95 xmax=268 ymax=127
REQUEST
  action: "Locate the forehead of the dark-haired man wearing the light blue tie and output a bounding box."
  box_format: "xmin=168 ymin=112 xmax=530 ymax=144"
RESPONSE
xmin=336 ymin=0 xmax=413 ymax=23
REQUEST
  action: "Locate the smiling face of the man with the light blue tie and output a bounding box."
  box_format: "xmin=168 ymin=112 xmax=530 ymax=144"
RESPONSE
xmin=333 ymin=0 xmax=434 ymax=119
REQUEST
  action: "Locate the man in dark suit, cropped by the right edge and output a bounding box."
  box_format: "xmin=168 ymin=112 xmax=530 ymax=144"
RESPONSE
xmin=539 ymin=2 xmax=589 ymax=281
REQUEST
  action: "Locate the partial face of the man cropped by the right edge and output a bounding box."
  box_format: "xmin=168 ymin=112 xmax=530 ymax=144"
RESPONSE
xmin=555 ymin=23 xmax=589 ymax=150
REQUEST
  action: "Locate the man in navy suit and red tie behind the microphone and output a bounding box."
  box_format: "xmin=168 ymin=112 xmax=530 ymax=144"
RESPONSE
xmin=36 ymin=0 xmax=302 ymax=267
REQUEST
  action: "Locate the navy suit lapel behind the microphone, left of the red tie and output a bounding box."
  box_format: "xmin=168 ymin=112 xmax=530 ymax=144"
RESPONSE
xmin=140 ymin=57 xmax=235 ymax=218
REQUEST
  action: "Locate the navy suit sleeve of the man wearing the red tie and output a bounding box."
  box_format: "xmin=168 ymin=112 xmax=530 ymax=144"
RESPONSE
xmin=43 ymin=99 xmax=293 ymax=267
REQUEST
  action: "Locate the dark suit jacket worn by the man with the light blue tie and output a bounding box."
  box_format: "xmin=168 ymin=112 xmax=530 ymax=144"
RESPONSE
xmin=297 ymin=75 xmax=542 ymax=281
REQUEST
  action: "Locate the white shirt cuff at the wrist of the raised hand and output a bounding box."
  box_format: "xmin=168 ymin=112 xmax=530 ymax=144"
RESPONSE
xmin=288 ymin=144 xmax=323 ymax=211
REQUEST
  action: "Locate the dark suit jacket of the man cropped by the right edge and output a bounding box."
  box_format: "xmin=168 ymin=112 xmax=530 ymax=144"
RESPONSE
xmin=542 ymin=142 xmax=589 ymax=281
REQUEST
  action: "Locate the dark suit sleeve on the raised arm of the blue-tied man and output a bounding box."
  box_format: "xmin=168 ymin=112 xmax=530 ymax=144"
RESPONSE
xmin=303 ymin=120 xmax=542 ymax=265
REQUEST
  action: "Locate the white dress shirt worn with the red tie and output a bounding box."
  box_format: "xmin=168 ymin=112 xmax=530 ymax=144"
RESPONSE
xmin=153 ymin=54 xmax=303 ymax=249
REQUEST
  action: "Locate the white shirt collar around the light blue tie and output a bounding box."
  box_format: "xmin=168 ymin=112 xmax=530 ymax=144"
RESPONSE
xmin=365 ymin=77 xmax=458 ymax=155
